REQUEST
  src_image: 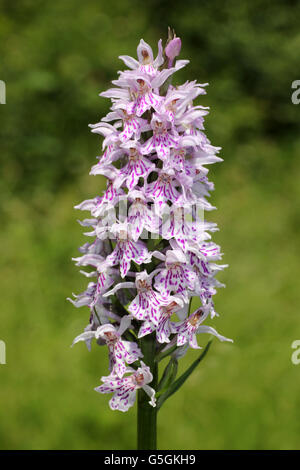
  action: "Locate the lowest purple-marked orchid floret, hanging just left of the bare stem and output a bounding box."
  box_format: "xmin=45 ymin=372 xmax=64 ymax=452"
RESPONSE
xmin=95 ymin=361 xmax=156 ymax=411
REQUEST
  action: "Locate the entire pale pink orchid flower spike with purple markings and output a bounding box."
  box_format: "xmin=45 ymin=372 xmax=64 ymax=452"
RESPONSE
xmin=71 ymin=37 xmax=232 ymax=411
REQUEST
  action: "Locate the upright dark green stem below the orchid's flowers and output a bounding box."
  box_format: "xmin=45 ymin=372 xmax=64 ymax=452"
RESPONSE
xmin=137 ymin=333 xmax=158 ymax=450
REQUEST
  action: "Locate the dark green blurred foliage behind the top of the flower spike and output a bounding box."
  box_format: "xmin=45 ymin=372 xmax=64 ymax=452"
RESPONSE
xmin=0 ymin=0 xmax=300 ymax=193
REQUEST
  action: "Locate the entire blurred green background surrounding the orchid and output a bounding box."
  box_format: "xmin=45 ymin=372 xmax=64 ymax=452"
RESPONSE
xmin=0 ymin=0 xmax=300 ymax=449
